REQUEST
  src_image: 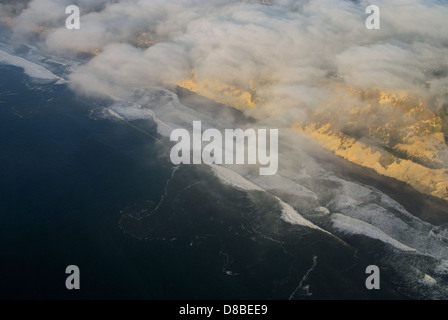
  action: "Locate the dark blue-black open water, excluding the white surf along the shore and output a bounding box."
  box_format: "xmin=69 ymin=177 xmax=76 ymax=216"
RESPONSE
xmin=0 ymin=66 xmax=402 ymax=299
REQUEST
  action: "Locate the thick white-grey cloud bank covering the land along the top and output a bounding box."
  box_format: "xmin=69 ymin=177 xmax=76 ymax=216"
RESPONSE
xmin=2 ymin=0 xmax=448 ymax=125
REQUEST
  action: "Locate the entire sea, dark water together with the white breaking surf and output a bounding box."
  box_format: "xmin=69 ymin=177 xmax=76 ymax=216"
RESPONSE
xmin=0 ymin=46 xmax=448 ymax=300
